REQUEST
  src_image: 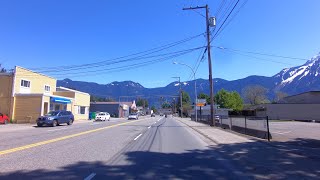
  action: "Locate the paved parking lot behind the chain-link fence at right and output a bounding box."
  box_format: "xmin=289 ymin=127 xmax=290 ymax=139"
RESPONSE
xmin=270 ymin=121 xmax=320 ymax=148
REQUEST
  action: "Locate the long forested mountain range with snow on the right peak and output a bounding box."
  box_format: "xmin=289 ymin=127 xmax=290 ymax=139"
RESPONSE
xmin=57 ymin=53 xmax=320 ymax=103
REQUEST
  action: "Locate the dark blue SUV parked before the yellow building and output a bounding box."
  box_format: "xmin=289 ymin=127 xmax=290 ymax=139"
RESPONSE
xmin=37 ymin=111 xmax=74 ymax=127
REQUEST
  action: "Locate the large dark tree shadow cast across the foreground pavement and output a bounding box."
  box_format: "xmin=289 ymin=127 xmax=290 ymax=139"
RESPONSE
xmin=0 ymin=139 xmax=320 ymax=179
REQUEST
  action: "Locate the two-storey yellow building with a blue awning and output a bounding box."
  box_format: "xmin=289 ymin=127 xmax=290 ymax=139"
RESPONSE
xmin=0 ymin=66 xmax=90 ymax=123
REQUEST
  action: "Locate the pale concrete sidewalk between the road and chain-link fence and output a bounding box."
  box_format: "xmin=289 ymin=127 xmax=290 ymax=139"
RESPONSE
xmin=176 ymin=118 xmax=254 ymax=144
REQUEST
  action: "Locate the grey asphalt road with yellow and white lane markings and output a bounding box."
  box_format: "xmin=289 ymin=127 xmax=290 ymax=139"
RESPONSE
xmin=0 ymin=116 xmax=246 ymax=179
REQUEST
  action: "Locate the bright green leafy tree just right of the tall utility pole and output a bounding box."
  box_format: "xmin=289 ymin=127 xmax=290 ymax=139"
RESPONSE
xmin=214 ymin=89 xmax=243 ymax=111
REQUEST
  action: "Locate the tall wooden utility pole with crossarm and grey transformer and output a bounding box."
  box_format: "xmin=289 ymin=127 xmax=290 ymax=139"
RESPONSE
xmin=182 ymin=5 xmax=215 ymax=126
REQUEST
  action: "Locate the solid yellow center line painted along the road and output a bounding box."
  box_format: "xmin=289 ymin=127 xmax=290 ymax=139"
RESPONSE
xmin=0 ymin=119 xmax=144 ymax=156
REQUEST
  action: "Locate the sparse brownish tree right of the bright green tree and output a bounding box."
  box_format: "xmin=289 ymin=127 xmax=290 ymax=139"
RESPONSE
xmin=242 ymin=85 xmax=269 ymax=105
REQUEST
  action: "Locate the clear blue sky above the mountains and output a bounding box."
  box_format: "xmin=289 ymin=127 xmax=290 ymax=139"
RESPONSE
xmin=0 ymin=0 xmax=320 ymax=87
